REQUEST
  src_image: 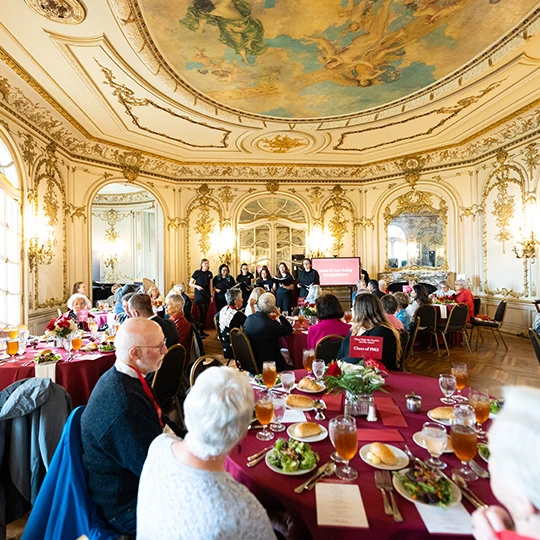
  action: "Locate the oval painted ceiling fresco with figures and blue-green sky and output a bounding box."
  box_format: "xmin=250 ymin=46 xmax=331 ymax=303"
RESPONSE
xmin=138 ymin=0 xmax=537 ymax=119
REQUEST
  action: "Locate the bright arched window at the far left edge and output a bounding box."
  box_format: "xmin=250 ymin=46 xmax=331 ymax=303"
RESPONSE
xmin=0 ymin=139 xmax=22 ymax=326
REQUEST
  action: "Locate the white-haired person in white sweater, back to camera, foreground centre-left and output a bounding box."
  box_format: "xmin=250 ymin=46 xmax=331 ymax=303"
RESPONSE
xmin=137 ymin=367 xmax=275 ymax=540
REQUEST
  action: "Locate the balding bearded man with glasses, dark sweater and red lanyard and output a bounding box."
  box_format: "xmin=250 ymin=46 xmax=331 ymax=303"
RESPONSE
xmin=81 ymin=318 xmax=181 ymax=535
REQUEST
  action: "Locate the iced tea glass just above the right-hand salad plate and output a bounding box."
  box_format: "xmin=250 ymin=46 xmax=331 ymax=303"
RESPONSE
xmin=450 ymin=405 xmax=478 ymax=482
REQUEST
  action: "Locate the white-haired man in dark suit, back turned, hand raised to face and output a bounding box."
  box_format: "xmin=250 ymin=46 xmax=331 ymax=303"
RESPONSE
xmin=244 ymin=293 xmax=293 ymax=373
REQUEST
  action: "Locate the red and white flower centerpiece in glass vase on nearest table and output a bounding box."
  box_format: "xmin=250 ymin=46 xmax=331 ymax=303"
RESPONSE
xmin=324 ymin=360 xmax=388 ymax=416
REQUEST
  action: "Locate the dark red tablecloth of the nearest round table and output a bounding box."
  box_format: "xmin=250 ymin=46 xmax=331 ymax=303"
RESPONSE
xmin=226 ymin=370 xmax=496 ymax=540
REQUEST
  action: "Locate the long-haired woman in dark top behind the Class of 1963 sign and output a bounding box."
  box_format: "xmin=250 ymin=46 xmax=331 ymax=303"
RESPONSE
xmin=338 ymin=294 xmax=401 ymax=370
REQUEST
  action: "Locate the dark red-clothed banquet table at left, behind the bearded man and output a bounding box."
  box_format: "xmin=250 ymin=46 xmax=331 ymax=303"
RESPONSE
xmin=0 ymin=343 xmax=116 ymax=407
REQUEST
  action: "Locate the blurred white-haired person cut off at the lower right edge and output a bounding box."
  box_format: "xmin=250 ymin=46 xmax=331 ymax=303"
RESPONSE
xmin=473 ymin=386 xmax=540 ymax=540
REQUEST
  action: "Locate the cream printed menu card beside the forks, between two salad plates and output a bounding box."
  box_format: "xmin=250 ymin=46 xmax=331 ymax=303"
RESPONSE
xmin=315 ymin=483 xmax=369 ymax=529
